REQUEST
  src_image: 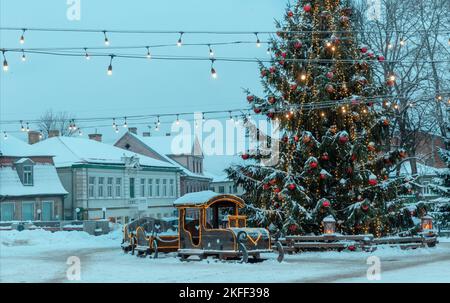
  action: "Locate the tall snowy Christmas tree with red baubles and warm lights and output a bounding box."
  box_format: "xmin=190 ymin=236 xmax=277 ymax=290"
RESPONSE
xmin=227 ymin=0 xmax=413 ymax=236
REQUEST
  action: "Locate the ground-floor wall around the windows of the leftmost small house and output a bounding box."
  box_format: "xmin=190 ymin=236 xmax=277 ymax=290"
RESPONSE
xmin=0 ymin=196 xmax=63 ymax=221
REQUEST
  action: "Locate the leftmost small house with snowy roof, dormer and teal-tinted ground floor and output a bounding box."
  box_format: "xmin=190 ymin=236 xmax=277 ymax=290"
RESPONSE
xmin=0 ymin=136 xmax=68 ymax=222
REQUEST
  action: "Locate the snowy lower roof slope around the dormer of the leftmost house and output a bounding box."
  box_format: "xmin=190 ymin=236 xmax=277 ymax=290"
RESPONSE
xmin=0 ymin=164 xmax=67 ymax=197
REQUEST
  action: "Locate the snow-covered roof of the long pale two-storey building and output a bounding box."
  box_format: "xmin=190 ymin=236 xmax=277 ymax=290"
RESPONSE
xmin=33 ymin=137 xmax=176 ymax=168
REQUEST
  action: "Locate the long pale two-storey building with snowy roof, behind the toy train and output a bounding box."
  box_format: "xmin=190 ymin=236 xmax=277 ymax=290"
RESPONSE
xmin=34 ymin=134 xmax=180 ymax=223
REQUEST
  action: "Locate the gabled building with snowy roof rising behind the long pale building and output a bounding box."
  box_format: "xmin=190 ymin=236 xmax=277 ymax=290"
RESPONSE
xmin=114 ymin=129 xmax=212 ymax=196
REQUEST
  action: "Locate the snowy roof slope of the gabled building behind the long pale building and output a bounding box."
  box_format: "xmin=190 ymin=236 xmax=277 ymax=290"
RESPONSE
xmin=128 ymin=133 xmax=210 ymax=179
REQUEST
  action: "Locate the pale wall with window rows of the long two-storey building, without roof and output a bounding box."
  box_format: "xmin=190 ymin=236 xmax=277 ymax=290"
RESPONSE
xmin=59 ymin=165 xmax=180 ymax=221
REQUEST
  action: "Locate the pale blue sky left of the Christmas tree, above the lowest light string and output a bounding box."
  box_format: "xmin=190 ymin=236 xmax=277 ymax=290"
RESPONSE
xmin=0 ymin=0 xmax=286 ymax=140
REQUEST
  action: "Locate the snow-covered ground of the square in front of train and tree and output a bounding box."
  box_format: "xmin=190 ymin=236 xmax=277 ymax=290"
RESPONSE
xmin=0 ymin=230 xmax=450 ymax=283
